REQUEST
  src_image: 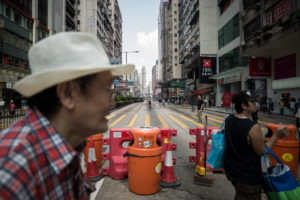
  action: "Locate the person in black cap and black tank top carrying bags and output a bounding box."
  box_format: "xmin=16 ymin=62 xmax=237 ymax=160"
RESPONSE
xmin=224 ymin=91 xmax=289 ymax=200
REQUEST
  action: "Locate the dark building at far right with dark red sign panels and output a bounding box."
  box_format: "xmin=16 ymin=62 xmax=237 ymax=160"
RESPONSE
xmin=240 ymin=0 xmax=300 ymax=114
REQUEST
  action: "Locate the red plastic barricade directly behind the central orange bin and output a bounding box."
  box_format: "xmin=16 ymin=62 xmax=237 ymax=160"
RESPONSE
xmin=101 ymin=128 xmax=177 ymax=180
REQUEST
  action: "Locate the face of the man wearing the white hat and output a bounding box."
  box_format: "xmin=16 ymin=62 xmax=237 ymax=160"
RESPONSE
xmin=75 ymin=71 xmax=115 ymax=135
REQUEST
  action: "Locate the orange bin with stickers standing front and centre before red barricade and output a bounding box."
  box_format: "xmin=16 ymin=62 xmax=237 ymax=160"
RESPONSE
xmin=127 ymin=128 xmax=162 ymax=194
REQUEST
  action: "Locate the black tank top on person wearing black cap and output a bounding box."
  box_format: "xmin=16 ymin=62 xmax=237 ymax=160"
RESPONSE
xmin=224 ymin=115 xmax=261 ymax=184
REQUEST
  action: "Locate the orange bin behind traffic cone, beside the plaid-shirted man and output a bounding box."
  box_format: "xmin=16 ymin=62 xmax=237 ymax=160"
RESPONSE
xmin=84 ymin=133 xmax=103 ymax=168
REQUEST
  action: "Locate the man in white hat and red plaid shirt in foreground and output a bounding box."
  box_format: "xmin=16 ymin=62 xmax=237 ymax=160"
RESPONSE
xmin=0 ymin=32 xmax=134 ymax=200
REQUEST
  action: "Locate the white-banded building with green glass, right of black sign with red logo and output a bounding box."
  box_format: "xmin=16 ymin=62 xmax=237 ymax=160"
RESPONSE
xmin=210 ymin=0 xmax=249 ymax=107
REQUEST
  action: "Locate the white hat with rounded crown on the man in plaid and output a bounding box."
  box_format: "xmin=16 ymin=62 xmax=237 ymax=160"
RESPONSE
xmin=13 ymin=32 xmax=134 ymax=97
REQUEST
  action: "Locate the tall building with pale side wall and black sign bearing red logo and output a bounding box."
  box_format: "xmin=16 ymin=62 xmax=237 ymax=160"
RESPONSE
xmin=179 ymin=0 xmax=217 ymax=102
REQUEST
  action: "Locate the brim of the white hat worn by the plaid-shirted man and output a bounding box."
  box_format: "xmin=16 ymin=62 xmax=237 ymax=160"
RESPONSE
xmin=13 ymin=63 xmax=135 ymax=97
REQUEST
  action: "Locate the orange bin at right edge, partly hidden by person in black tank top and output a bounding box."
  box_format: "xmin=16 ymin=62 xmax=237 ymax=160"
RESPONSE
xmin=266 ymin=123 xmax=299 ymax=178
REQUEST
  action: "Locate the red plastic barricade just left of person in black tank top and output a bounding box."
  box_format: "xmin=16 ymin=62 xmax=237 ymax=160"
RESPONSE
xmin=189 ymin=126 xmax=224 ymax=172
